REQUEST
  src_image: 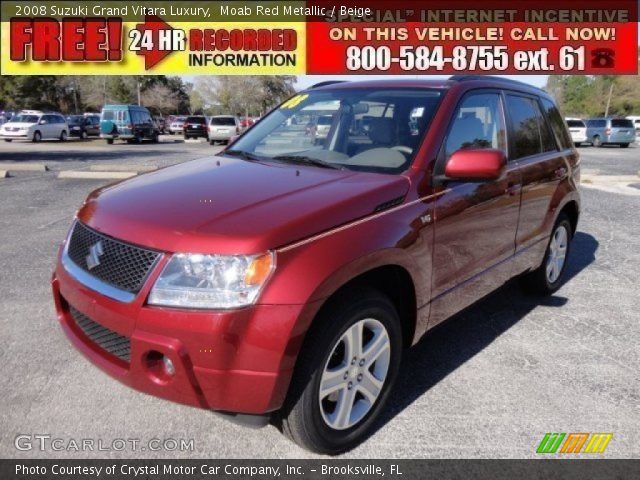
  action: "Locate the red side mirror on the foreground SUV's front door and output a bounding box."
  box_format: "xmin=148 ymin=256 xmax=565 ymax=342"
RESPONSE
xmin=444 ymin=148 xmax=507 ymax=181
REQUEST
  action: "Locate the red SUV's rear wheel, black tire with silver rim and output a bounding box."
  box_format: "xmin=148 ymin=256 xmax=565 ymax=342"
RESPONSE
xmin=522 ymin=213 xmax=573 ymax=295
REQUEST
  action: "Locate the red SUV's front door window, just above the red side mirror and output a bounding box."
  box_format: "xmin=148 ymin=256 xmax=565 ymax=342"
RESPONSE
xmin=445 ymin=93 xmax=507 ymax=159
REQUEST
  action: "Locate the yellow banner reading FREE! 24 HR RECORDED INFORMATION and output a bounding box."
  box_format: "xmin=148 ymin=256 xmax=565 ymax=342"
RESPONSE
xmin=0 ymin=17 xmax=306 ymax=75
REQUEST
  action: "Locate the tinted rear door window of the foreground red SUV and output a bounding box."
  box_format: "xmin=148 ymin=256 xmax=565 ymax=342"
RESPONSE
xmin=507 ymin=95 xmax=542 ymax=159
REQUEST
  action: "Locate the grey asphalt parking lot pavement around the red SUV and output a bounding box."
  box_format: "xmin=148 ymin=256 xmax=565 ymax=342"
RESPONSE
xmin=0 ymin=142 xmax=640 ymax=458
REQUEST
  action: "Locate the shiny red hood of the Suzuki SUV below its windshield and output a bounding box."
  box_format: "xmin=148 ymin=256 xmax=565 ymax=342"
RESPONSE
xmin=78 ymin=156 xmax=409 ymax=254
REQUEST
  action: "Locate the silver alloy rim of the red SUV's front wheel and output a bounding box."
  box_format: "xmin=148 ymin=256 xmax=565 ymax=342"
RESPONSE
xmin=318 ymin=318 xmax=391 ymax=430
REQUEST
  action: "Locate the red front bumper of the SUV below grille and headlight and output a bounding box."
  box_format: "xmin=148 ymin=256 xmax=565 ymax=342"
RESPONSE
xmin=52 ymin=263 xmax=303 ymax=414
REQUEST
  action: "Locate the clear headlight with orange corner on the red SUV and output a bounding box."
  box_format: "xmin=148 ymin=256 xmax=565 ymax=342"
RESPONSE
xmin=149 ymin=252 xmax=275 ymax=309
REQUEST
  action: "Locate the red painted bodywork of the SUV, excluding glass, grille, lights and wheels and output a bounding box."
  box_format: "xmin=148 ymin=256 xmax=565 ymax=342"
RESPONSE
xmin=52 ymin=80 xmax=579 ymax=414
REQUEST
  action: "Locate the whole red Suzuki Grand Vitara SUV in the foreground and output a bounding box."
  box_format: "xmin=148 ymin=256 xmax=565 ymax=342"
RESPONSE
xmin=52 ymin=76 xmax=580 ymax=454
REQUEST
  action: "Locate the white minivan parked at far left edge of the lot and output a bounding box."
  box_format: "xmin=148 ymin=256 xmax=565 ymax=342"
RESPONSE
xmin=0 ymin=110 xmax=69 ymax=142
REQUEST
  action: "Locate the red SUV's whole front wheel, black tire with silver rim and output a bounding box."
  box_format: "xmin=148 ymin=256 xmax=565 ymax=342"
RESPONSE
xmin=281 ymin=289 xmax=403 ymax=455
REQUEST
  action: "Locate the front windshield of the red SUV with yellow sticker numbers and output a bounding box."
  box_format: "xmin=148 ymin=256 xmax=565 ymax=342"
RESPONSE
xmin=230 ymin=88 xmax=442 ymax=173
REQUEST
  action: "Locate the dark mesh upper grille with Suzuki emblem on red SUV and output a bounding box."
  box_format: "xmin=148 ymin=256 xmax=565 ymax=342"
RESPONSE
xmin=67 ymin=222 xmax=161 ymax=293
